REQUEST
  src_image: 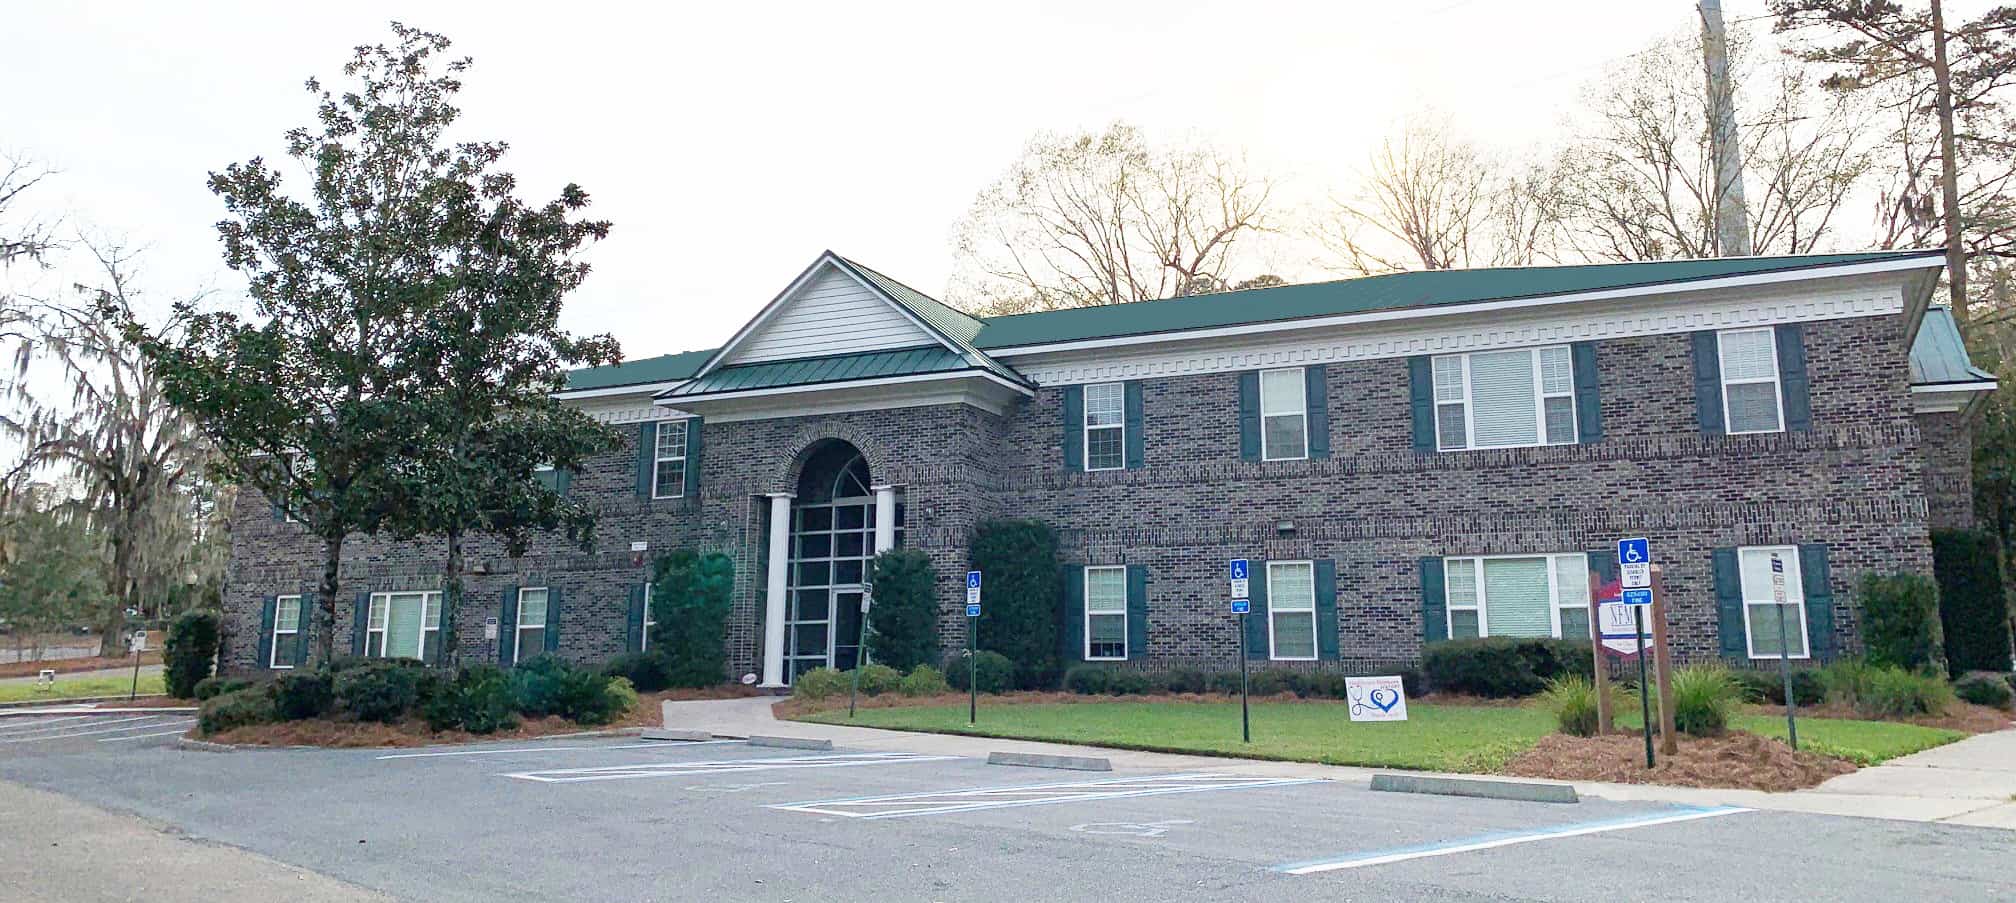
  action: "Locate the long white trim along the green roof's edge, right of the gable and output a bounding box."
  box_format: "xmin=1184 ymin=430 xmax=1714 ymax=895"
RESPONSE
xmin=986 ymin=256 xmax=1945 ymax=357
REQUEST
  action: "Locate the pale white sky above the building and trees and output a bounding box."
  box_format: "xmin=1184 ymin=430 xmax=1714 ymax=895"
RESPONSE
xmin=0 ymin=0 xmax=1798 ymax=359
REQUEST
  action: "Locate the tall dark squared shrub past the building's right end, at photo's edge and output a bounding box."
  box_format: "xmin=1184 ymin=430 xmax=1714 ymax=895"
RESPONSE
xmin=1931 ymin=530 xmax=2010 ymax=675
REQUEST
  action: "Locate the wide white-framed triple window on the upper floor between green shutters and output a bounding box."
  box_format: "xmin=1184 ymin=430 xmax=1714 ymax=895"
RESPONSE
xmin=1433 ymin=345 xmax=1577 ymax=452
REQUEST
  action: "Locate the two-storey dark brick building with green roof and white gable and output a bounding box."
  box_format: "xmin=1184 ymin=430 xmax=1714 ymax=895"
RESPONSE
xmin=226 ymin=252 xmax=1996 ymax=685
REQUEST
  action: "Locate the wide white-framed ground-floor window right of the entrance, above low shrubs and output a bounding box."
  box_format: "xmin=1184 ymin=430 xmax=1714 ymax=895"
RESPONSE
xmin=1441 ymin=552 xmax=1589 ymax=639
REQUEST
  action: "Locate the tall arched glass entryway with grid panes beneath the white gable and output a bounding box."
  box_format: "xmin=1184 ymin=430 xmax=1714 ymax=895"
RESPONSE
xmin=784 ymin=439 xmax=903 ymax=681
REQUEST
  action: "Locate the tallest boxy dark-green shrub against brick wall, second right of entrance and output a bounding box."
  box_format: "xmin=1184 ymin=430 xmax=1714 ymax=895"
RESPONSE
xmin=972 ymin=520 xmax=1064 ymax=689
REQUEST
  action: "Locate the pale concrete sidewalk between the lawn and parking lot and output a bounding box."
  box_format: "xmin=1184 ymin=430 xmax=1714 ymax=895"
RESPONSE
xmin=665 ymin=697 xmax=2016 ymax=830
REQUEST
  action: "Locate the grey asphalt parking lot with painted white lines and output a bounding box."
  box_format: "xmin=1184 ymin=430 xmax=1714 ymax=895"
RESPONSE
xmin=0 ymin=722 xmax=2016 ymax=903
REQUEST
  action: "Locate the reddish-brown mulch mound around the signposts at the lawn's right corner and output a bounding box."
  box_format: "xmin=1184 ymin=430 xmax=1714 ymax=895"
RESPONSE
xmin=1504 ymin=732 xmax=1855 ymax=792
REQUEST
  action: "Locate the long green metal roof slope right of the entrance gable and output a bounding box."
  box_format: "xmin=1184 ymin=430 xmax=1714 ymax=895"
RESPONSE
xmin=974 ymin=250 xmax=1937 ymax=349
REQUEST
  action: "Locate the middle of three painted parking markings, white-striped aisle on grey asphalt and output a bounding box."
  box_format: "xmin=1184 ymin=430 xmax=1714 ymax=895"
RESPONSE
xmin=770 ymin=772 xmax=1322 ymax=818
